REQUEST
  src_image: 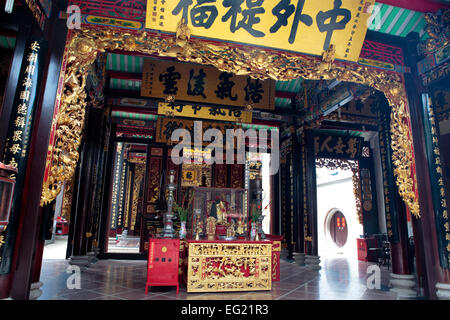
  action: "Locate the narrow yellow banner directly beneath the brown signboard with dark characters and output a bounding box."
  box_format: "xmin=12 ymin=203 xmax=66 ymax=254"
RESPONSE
xmin=158 ymin=102 xmax=252 ymax=123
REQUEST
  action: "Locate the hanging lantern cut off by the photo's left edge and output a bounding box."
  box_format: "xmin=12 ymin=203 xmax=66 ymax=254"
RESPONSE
xmin=0 ymin=162 xmax=17 ymax=232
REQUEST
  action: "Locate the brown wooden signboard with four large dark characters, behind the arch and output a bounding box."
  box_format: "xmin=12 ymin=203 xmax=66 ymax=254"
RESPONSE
xmin=141 ymin=59 xmax=275 ymax=110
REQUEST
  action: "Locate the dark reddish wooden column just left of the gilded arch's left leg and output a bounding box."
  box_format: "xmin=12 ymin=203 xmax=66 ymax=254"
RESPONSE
xmin=11 ymin=16 xmax=67 ymax=299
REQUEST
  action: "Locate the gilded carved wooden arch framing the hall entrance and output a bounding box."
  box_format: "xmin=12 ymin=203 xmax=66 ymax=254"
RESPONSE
xmin=41 ymin=25 xmax=420 ymax=218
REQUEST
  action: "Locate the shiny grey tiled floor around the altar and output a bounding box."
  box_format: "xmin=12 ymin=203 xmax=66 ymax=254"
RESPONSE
xmin=39 ymin=252 xmax=412 ymax=300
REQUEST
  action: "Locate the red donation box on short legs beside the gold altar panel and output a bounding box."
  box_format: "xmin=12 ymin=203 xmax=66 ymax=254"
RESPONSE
xmin=145 ymin=238 xmax=180 ymax=294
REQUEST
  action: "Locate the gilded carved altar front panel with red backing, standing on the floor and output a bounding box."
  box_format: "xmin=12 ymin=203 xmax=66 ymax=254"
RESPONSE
xmin=187 ymin=241 xmax=272 ymax=292
